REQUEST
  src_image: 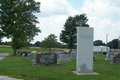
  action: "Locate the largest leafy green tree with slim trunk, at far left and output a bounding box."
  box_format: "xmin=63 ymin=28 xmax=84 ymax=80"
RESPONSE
xmin=0 ymin=0 xmax=41 ymax=55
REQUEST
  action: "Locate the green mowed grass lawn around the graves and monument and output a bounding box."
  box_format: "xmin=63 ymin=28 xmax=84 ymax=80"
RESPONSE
xmin=0 ymin=48 xmax=120 ymax=80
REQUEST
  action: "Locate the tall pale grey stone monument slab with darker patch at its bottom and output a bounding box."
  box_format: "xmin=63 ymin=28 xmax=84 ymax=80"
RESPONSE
xmin=76 ymin=27 xmax=93 ymax=73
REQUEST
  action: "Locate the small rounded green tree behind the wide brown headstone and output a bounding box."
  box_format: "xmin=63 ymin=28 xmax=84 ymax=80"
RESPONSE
xmin=40 ymin=34 xmax=57 ymax=52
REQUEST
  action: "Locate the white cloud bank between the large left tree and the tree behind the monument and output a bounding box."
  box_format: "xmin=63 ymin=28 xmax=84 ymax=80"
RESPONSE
xmin=34 ymin=0 xmax=79 ymax=42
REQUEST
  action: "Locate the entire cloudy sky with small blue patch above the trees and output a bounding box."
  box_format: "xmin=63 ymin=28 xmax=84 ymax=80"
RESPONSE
xmin=3 ymin=0 xmax=120 ymax=43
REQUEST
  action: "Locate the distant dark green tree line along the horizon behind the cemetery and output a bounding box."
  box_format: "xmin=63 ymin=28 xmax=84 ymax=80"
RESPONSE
xmin=0 ymin=37 xmax=120 ymax=49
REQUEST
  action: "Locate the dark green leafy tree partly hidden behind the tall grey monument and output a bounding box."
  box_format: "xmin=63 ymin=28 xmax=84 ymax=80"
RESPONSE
xmin=60 ymin=14 xmax=89 ymax=52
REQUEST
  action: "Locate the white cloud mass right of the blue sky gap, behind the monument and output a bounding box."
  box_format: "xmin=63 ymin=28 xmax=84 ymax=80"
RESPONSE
xmin=81 ymin=0 xmax=120 ymax=42
